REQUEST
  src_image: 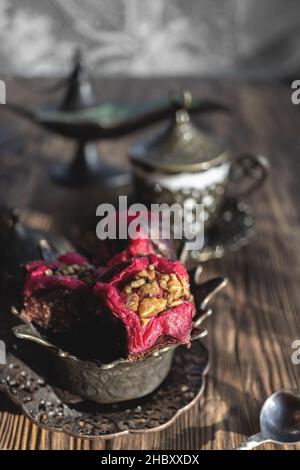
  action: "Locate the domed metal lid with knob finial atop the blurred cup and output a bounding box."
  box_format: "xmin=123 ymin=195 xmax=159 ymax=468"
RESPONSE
xmin=129 ymin=91 xmax=228 ymax=173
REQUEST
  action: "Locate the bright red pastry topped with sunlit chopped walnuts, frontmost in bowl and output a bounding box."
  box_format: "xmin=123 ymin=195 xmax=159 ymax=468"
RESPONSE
xmin=94 ymin=254 xmax=195 ymax=357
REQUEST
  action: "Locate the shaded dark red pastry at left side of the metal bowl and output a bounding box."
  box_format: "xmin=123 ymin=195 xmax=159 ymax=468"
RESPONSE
xmin=21 ymin=253 xmax=95 ymax=331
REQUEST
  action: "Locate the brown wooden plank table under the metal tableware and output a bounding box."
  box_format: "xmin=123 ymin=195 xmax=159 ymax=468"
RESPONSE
xmin=0 ymin=79 xmax=300 ymax=449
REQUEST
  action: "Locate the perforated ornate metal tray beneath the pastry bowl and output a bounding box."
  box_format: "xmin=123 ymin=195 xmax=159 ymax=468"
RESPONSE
xmin=0 ymin=341 xmax=208 ymax=439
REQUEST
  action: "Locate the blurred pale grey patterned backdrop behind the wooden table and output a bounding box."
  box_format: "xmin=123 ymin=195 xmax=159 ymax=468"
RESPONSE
xmin=0 ymin=0 xmax=300 ymax=80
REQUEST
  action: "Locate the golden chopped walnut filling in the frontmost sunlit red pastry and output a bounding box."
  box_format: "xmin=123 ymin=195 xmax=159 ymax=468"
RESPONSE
xmin=123 ymin=265 xmax=193 ymax=326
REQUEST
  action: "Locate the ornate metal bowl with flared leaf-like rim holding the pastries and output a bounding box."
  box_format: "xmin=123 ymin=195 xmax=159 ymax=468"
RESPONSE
xmin=13 ymin=274 xmax=227 ymax=404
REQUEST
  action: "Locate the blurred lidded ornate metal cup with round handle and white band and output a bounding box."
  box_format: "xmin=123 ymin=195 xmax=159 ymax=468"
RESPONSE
xmin=129 ymin=92 xmax=267 ymax=231
